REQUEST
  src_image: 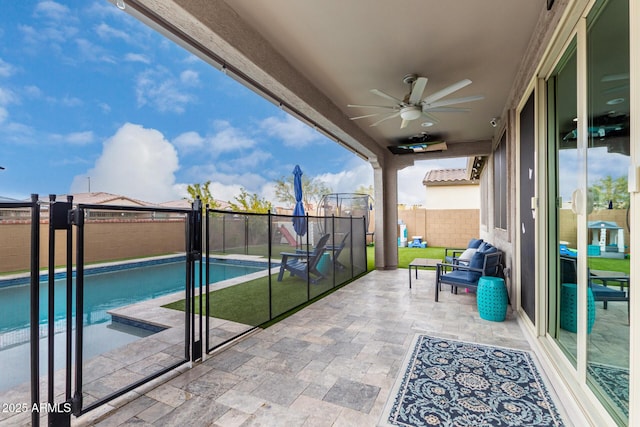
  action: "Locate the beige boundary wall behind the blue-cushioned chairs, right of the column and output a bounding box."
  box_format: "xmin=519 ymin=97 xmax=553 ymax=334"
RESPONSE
xmin=398 ymin=208 xmax=480 ymax=248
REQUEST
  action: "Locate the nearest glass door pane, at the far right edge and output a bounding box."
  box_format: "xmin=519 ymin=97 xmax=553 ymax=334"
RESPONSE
xmin=586 ymin=0 xmax=631 ymax=424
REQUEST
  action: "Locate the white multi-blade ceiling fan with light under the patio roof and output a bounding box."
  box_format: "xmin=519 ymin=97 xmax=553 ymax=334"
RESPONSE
xmin=347 ymin=74 xmax=484 ymax=129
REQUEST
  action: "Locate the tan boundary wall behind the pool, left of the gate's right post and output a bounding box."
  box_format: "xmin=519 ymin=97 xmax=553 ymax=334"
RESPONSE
xmin=0 ymin=219 xmax=185 ymax=273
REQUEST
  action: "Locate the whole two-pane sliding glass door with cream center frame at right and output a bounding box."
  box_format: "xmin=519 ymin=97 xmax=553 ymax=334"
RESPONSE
xmin=546 ymin=0 xmax=632 ymax=425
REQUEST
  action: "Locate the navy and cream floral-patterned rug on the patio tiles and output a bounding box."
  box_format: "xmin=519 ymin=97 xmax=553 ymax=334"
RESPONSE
xmin=380 ymin=335 xmax=563 ymax=427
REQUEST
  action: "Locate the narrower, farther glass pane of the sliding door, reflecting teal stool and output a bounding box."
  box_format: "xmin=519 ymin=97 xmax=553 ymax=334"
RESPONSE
xmin=547 ymin=39 xmax=581 ymax=366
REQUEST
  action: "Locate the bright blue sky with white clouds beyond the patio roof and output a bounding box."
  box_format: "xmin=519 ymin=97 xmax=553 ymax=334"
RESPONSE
xmin=0 ymin=0 xmax=464 ymax=204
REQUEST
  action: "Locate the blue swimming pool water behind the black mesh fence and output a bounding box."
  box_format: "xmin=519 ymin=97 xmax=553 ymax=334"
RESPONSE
xmin=0 ymin=257 xmax=268 ymax=390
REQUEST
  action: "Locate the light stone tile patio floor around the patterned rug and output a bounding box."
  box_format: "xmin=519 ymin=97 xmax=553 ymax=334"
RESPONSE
xmin=67 ymin=269 xmax=568 ymax=427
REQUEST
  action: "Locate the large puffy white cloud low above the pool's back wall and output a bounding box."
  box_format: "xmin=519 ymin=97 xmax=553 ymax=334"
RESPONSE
xmin=70 ymin=123 xmax=182 ymax=202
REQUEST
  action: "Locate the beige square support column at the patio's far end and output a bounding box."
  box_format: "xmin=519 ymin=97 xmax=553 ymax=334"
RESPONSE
xmin=373 ymin=162 xmax=398 ymax=270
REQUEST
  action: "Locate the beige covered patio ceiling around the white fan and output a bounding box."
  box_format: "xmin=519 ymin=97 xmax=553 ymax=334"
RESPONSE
xmin=129 ymin=0 xmax=547 ymax=165
